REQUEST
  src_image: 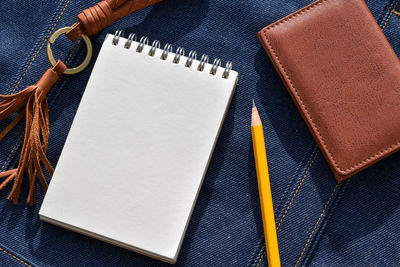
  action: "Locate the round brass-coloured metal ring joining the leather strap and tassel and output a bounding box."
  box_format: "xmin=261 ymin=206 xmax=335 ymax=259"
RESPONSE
xmin=47 ymin=27 xmax=93 ymax=74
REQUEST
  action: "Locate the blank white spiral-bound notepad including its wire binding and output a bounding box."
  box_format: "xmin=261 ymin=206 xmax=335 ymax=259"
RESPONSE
xmin=39 ymin=31 xmax=238 ymax=263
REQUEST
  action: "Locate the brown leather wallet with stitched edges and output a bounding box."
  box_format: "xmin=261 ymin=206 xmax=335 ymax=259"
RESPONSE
xmin=258 ymin=0 xmax=400 ymax=181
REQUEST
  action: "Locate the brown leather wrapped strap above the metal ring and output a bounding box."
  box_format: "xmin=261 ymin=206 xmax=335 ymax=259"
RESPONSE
xmin=66 ymin=0 xmax=162 ymax=41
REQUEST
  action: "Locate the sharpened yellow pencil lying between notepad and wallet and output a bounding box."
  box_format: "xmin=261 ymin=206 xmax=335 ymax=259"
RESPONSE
xmin=251 ymin=99 xmax=281 ymax=267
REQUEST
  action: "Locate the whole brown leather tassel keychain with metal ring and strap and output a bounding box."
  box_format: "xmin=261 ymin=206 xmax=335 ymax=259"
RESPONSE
xmin=0 ymin=0 xmax=162 ymax=206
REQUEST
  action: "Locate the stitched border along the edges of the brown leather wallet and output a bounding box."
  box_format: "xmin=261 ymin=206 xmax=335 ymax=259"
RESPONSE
xmin=263 ymin=0 xmax=400 ymax=175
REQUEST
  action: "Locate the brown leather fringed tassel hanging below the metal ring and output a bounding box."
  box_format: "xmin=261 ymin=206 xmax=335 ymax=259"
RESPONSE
xmin=0 ymin=60 xmax=67 ymax=206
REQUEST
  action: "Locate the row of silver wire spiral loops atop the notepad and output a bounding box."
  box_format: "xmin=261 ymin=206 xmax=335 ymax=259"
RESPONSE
xmin=112 ymin=30 xmax=232 ymax=79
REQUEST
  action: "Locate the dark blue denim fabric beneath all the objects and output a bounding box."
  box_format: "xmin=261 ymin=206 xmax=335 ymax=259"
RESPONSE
xmin=0 ymin=0 xmax=400 ymax=266
